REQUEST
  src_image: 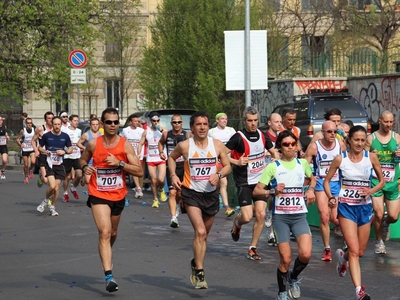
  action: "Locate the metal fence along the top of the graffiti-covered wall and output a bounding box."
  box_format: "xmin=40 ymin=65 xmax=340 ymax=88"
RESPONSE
xmin=268 ymin=48 xmax=400 ymax=79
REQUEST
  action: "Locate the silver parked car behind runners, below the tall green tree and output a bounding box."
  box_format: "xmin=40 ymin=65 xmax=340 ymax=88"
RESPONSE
xmin=124 ymin=108 xmax=196 ymax=131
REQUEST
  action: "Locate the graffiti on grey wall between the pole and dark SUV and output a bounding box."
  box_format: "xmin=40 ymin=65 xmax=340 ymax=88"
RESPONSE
xmin=251 ymin=82 xmax=293 ymax=117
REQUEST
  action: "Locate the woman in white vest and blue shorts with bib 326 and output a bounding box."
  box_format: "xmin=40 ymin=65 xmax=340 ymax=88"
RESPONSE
xmin=324 ymin=125 xmax=385 ymax=300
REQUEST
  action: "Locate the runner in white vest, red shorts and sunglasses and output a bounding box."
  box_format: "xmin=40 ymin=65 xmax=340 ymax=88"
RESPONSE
xmin=138 ymin=111 xmax=167 ymax=208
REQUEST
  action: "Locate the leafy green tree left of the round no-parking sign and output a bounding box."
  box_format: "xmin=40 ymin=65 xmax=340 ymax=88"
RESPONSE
xmin=0 ymin=0 xmax=98 ymax=108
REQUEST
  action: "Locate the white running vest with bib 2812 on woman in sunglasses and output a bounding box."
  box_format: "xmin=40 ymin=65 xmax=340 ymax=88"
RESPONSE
xmin=274 ymin=158 xmax=308 ymax=214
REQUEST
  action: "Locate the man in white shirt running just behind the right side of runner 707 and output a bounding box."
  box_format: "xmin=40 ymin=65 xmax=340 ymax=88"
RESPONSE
xmin=121 ymin=114 xmax=144 ymax=198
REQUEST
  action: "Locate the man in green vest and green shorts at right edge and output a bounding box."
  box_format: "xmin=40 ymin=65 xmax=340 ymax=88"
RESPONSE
xmin=366 ymin=110 xmax=400 ymax=254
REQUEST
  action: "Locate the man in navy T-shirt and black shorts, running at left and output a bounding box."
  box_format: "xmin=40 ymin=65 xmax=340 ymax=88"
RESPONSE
xmin=37 ymin=117 xmax=72 ymax=217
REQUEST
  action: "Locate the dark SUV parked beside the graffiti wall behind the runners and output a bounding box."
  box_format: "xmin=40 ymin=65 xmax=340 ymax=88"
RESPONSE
xmin=273 ymin=91 xmax=371 ymax=149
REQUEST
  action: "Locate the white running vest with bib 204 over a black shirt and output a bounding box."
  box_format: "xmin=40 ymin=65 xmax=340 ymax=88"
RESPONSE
xmin=238 ymin=129 xmax=265 ymax=185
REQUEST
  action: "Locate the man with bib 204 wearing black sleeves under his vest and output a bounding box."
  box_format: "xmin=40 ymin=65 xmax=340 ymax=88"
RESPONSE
xmin=225 ymin=106 xmax=279 ymax=260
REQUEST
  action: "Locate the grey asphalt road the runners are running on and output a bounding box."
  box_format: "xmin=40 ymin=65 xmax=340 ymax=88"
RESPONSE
xmin=0 ymin=170 xmax=400 ymax=300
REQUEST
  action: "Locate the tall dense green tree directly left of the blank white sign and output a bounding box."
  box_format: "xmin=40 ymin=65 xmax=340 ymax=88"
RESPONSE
xmin=138 ymin=0 xmax=244 ymax=116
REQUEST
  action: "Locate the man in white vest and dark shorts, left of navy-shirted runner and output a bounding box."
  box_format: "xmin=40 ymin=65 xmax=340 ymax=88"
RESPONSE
xmin=17 ymin=118 xmax=36 ymax=184
